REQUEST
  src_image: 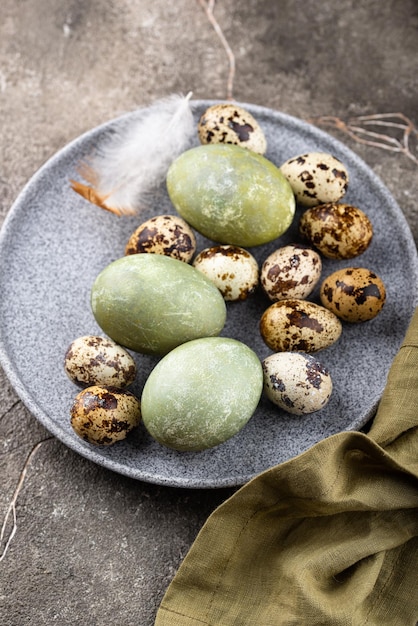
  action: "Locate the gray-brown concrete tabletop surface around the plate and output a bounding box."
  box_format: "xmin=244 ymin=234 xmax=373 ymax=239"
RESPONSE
xmin=0 ymin=0 xmax=418 ymax=626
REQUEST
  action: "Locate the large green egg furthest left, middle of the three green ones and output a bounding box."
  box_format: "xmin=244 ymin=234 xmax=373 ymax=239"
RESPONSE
xmin=91 ymin=254 xmax=226 ymax=354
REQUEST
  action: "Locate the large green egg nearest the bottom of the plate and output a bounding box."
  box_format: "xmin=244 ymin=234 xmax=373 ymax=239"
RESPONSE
xmin=141 ymin=337 xmax=263 ymax=451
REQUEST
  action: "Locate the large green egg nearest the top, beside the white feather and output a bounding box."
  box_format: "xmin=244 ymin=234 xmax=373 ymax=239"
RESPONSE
xmin=167 ymin=144 xmax=296 ymax=247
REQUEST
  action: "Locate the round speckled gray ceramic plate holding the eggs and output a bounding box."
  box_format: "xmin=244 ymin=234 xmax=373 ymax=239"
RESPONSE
xmin=0 ymin=101 xmax=417 ymax=488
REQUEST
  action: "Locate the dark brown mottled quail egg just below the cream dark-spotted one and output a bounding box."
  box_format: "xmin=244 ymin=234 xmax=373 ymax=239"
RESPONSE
xmin=299 ymin=202 xmax=373 ymax=259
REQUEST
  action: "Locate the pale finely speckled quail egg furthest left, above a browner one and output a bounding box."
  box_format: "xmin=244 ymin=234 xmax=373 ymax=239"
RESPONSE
xmin=64 ymin=335 xmax=136 ymax=389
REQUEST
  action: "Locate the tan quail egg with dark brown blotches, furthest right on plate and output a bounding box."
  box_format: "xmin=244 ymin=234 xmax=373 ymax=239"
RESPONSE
xmin=320 ymin=267 xmax=386 ymax=323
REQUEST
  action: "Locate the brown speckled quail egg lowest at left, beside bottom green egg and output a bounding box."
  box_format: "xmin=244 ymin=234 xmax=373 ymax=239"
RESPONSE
xmin=70 ymin=385 xmax=141 ymax=446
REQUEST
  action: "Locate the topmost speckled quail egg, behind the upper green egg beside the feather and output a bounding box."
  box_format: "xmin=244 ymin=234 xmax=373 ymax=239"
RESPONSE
xmin=198 ymin=103 xmax=267 ymax=154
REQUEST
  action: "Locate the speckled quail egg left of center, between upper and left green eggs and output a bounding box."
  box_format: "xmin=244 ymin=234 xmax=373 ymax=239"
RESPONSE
xmin=125 ymin=215 xmax=196 ymax=263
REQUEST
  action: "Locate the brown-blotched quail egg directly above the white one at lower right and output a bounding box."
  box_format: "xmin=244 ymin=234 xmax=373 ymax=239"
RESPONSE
xmin=260 ymin=299 xmax=342 ymax=353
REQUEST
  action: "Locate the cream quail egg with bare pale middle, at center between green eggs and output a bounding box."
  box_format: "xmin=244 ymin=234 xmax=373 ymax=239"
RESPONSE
xmin=193 ymin=245 xmax=259 ymax=301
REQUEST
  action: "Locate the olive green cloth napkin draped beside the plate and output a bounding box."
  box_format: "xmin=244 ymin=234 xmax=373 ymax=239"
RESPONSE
xmin=155 ymin=309 xmax=418 ymax=626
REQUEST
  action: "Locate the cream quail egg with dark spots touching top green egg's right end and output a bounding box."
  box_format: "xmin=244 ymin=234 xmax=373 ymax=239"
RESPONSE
xmin=280 ymin=152 xmax=349 ymax=206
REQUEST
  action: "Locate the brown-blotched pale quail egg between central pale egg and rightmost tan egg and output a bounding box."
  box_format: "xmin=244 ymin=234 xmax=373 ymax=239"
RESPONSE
xmin=260 ymin=244 xmax=322 ymax=302
